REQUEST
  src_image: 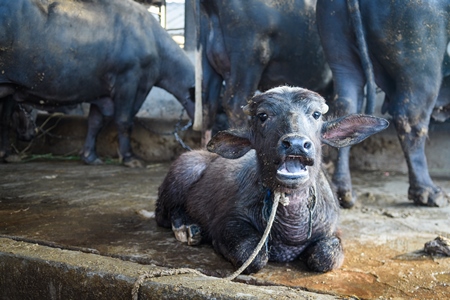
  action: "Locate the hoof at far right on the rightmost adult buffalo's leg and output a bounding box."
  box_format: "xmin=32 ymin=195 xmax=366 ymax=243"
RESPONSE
xmin=408 ymin=187 xmax=449 ymax=207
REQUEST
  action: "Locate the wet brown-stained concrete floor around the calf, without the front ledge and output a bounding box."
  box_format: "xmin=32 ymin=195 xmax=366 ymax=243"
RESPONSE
xmin=0 ymin=160 xmax=450 ymax=299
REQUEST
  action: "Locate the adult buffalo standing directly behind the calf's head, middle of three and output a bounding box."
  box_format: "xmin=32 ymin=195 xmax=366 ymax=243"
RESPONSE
xmin=199 ymin=0 xmax=332 ymax=130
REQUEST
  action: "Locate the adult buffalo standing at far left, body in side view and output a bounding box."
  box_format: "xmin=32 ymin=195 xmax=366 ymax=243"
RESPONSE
xmin=0 ymin=0 xmax=195 ymax=166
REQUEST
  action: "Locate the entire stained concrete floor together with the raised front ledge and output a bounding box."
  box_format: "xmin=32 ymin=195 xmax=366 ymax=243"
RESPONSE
xmin=0 ymin=159 xmax=450 ymax=299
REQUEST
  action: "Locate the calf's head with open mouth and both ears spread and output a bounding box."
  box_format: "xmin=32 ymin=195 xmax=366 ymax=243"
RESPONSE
xmin=208 ymin=86 xmax=388 ymax=190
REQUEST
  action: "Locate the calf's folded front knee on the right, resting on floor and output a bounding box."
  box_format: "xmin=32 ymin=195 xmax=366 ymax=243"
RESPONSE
xmin=303 ymin=236 xmax=344 ymax=273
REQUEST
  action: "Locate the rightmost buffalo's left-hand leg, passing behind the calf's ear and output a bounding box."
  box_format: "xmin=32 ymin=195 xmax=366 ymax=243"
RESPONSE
xmin=317 ymin=0 xmax=365 ymax=208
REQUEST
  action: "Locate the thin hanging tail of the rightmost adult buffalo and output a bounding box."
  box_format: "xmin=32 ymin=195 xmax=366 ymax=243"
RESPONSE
xmin=347 ymin=0 xmax=376 ymax=115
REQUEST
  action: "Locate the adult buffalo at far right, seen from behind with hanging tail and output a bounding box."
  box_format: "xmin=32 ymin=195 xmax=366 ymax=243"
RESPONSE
xmin=317 ymin=0 xmax=450 ymax=207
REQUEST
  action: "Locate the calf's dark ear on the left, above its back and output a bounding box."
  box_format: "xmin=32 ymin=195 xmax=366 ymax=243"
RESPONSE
xmin=206 ymin=129 xmax=252 ymax=159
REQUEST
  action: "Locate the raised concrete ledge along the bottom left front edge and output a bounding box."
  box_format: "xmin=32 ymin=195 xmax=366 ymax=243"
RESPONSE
xmin=0 ymin=238 xmax=335 ymax=300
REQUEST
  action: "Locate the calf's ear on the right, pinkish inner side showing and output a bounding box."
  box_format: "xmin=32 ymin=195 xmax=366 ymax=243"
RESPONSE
xmin=322 ymin=114 xmax=389 ymax=148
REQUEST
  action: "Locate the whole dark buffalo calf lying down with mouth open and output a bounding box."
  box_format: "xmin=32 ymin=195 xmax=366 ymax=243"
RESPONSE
xmin=155 ymin=87 xmax=388 ymax=273
